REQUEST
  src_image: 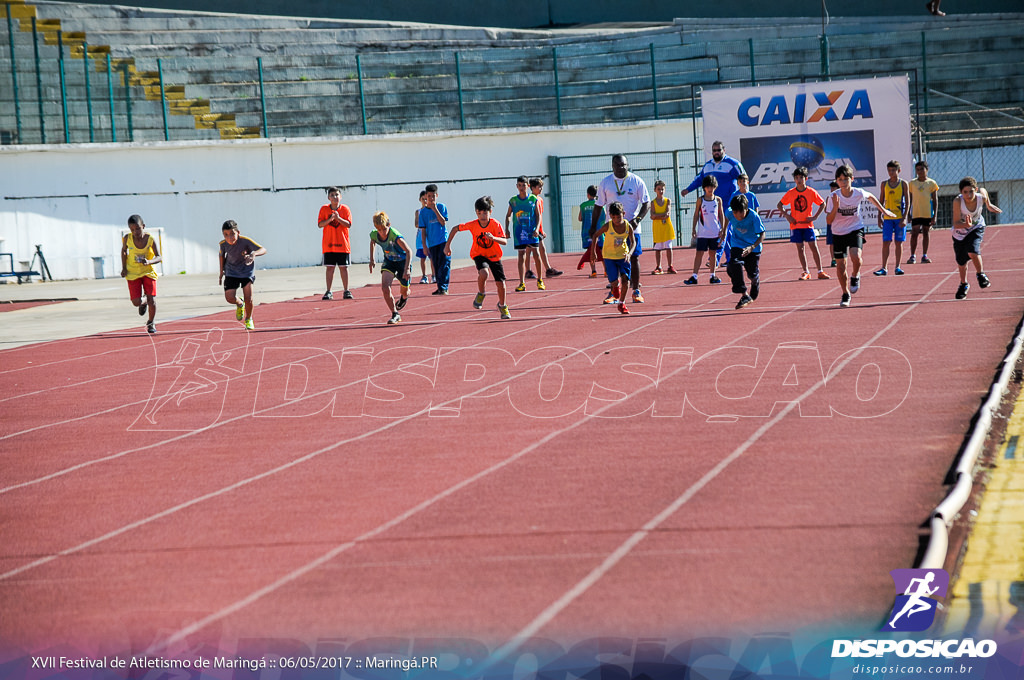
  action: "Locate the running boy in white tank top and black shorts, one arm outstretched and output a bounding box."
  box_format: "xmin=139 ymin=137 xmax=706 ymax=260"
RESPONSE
xmin=826 ymin=165 xmax=896 ymax=307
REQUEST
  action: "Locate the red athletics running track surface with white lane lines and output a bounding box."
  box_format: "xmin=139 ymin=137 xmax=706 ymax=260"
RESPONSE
xmin=0 ymin=227 xmax=1024 ymax=652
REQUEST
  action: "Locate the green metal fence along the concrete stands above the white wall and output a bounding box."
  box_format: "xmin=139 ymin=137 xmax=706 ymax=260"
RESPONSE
xmin=6 ymin=12 xmax=1024 ymax=143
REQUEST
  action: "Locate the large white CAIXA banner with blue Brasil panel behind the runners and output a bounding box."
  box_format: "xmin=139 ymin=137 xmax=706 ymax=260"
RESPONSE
xmin=701 ymin=76 xmax=913 ymax=230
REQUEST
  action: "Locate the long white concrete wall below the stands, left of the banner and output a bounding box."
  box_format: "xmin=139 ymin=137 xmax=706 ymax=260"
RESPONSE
xmin=0 ymin=121 xmax=693 ymax=279
